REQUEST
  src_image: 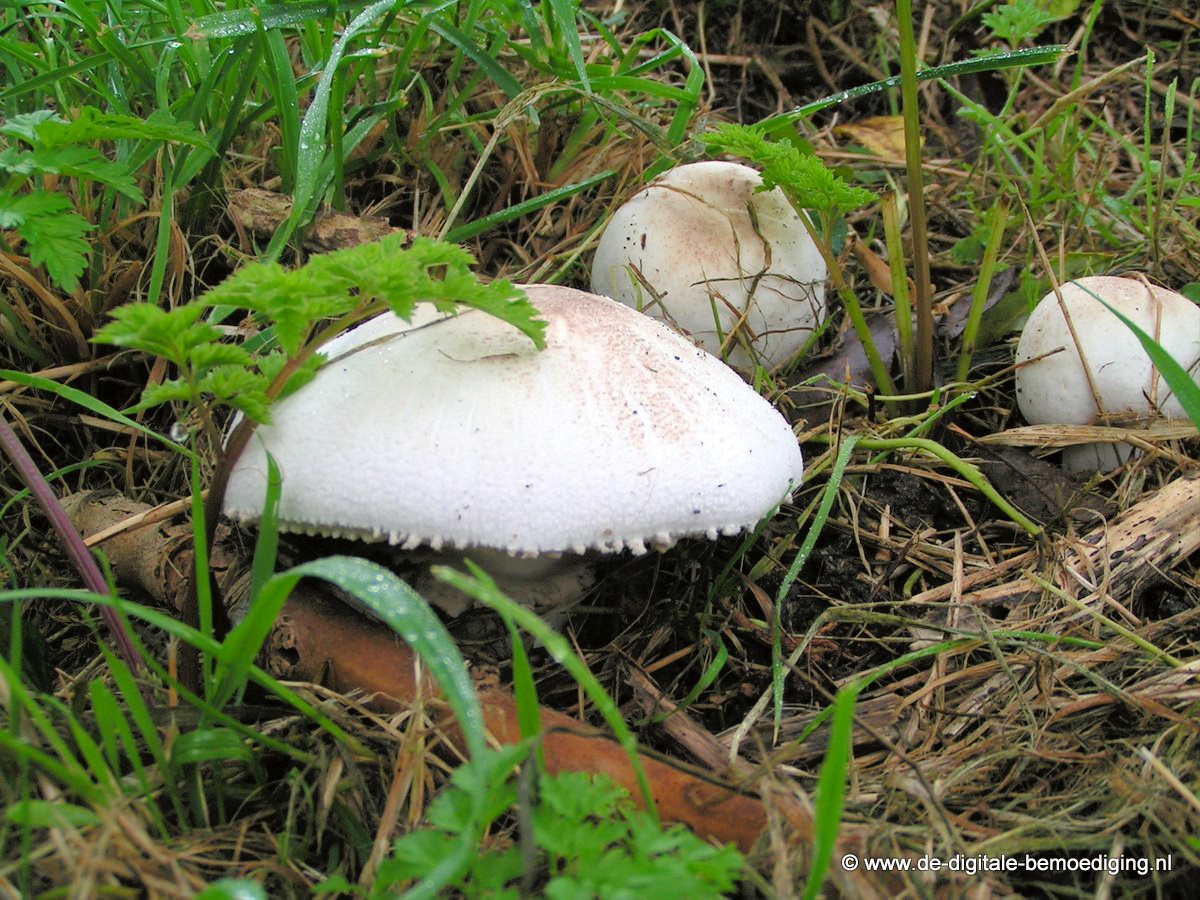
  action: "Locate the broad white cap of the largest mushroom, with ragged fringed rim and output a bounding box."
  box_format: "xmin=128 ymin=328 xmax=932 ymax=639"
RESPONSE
xmin=224 ymin=286 xmax=802 ymax=556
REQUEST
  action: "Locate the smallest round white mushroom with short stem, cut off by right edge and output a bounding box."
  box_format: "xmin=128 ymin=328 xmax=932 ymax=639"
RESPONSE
xmin=1016 ymin=276 xmax=1200 ymax=472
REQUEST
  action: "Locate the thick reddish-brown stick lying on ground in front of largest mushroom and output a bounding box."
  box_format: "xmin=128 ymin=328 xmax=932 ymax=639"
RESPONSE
xmin=62 ymin=494 xmax=768 ymax=852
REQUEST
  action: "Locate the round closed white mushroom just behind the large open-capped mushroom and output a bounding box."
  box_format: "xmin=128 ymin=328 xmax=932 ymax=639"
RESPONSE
xmin=592 ymin=162 xmax=828 ymax=367
